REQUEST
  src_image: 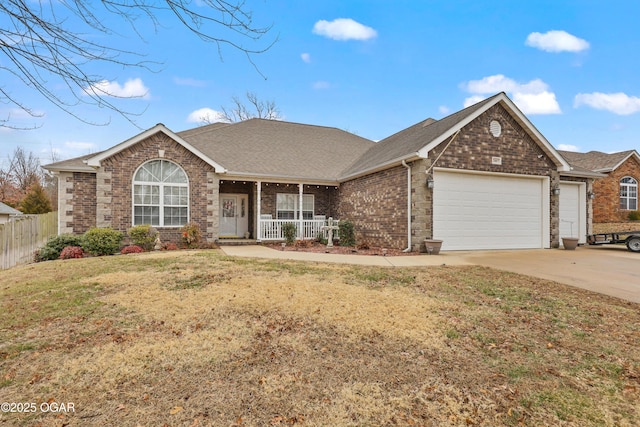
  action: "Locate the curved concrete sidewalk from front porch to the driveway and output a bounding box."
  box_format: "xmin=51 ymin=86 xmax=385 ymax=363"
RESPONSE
xmin=220 ymin=245 xmax=473 ymax=267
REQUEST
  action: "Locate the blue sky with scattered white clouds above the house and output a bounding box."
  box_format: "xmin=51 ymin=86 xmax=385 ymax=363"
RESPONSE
xmin=0 ymin=0 xmax=640 ymax=163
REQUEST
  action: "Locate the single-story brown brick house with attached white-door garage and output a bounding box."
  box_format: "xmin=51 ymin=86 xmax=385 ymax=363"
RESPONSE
xmin=46 ymin=93 xmax=599 ymax=250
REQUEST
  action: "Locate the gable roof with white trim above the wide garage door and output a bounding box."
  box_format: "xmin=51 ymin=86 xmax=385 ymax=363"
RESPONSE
xmin=343 ymin=92 xmax=570 ymax=179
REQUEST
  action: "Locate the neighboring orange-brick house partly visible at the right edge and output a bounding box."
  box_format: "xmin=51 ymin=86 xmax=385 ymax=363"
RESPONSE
xmin=560 ymin=150 xmax=640 ymax=223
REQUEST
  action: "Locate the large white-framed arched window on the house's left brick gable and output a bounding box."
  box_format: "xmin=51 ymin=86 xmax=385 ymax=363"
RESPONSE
xmin=133 ymin=160 xmax=189 ymax=227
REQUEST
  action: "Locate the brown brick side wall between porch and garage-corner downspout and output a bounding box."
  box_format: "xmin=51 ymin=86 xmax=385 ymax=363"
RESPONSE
xmin=336 ymin=166 xmax=407 ymax=249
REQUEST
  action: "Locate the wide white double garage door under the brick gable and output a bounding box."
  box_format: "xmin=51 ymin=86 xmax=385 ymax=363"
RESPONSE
xmin=433 ymin=170 xmax=549 ymax=250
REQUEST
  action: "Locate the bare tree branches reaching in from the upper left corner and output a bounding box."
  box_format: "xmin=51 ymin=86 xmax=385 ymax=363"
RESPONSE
xmin=0 ymin=0 xmax=275 ymax=127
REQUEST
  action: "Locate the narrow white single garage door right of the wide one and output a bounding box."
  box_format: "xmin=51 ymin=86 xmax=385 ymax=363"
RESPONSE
xmin=560 ymin=182 xmax=587 ymax=243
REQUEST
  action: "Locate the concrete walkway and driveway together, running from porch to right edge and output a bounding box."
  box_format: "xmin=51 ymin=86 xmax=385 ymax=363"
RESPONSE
xmin=221 ymin=245 xmax=640 ymax=303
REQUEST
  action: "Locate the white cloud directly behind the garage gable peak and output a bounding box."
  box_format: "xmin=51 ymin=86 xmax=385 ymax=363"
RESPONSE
xmin=463 ymin=74 xmax=562 ymax=114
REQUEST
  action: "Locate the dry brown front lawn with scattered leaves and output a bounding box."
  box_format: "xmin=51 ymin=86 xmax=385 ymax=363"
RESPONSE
xmin=0 ymin=251 xmax=640 ymax=426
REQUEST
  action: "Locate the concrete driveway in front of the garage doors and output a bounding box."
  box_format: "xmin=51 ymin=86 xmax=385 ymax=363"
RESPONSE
xmin=459 ymin=245 xmax=640 ymax=303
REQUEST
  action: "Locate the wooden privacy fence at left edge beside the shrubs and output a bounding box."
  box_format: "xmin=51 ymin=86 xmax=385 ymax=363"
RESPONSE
xmin=0 ymin=212 xmax=58 ymax=269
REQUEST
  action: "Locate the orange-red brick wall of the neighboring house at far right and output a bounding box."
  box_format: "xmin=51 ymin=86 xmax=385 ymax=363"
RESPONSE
xmin=593 ymin=157 xmax=640 ymax=222
